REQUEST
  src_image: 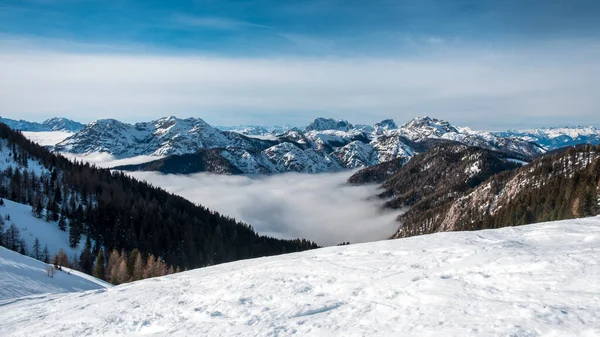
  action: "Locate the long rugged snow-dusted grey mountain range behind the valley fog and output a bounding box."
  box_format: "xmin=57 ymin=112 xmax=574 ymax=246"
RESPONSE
xmin=54 ymin=117 xmax=544 ymax=174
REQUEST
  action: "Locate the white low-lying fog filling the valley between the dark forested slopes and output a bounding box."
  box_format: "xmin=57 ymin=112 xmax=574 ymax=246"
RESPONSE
xmin=55 ymin=154 xmax=399 ymax=245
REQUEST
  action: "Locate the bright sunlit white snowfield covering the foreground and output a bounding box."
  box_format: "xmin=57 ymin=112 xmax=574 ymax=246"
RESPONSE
xmin=0 ymin=217 xmax=600 ymax=337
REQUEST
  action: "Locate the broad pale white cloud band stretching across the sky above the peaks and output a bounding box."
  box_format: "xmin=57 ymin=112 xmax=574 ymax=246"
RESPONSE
xmin=0 ymin=37 xmax=600 ymax=128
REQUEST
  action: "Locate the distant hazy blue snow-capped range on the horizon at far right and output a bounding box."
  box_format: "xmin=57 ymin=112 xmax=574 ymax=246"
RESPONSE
xmin=498 ymin=126 xmax=600 ymax=151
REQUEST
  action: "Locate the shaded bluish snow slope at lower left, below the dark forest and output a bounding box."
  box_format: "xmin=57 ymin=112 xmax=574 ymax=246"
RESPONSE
xmin=0 ymin=247 xmax=112 ymax=300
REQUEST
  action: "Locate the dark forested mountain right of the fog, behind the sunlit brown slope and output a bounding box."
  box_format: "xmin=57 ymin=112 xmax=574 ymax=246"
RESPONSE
xmin=349 ymin=142 xmax=520 ymax=223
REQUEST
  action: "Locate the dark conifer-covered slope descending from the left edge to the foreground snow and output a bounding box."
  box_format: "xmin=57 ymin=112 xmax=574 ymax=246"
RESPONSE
xmin=0 ymin=124 xmax=317 ymax=280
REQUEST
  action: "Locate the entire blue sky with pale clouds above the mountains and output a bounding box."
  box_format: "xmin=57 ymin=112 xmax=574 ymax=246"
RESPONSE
xmin=0 ymin=0 xmax=600 ymax=129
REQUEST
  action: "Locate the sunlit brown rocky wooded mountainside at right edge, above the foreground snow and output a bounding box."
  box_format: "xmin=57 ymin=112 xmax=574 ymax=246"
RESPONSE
xmin=394 ymin=145 xmax=600 ymax=237
